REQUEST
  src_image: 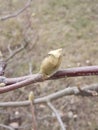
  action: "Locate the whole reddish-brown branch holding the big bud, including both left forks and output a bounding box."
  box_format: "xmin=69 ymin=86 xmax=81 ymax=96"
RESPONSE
xmin=0 ymin=66 xmax=98 ymax=94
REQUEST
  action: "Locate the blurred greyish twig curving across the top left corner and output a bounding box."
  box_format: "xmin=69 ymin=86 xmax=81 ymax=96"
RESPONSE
xmin=0 ymin=0 xmax=32 ymax=21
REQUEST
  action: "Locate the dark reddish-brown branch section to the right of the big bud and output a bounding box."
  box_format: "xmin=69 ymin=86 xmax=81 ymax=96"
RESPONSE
xmin=50 ymin=66 xmax=98 ymax=79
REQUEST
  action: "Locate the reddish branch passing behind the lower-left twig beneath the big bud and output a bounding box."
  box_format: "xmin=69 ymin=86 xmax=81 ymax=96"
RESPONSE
xmin=0 ymin=66 xmax=98 ymax=85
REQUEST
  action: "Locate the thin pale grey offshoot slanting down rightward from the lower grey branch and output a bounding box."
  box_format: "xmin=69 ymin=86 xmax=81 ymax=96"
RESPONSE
xmin=47 ymin=101 xmax=66 ymax=130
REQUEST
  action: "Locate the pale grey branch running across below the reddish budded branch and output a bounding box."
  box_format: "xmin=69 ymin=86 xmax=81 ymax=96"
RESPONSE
xmin=0 ymin=84 xmax=98 ymax=107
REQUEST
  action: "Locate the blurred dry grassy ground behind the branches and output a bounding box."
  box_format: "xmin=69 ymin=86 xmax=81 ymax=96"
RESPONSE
xmin=0 ymin=0 xmax=98 ymax=130
